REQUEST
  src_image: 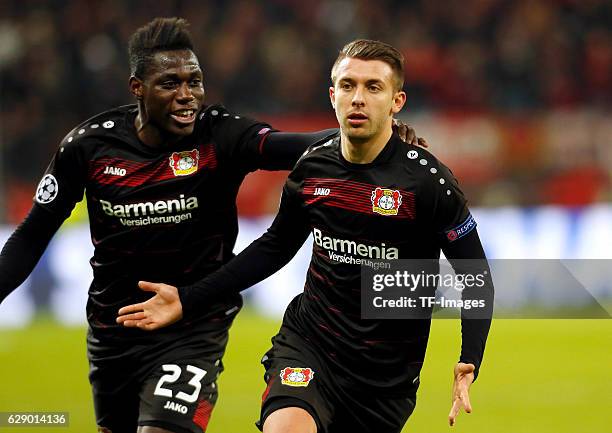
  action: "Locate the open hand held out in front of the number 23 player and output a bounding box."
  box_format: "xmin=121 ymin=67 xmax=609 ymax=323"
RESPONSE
xmin=117 ymin=281 xmax=183 ymax=331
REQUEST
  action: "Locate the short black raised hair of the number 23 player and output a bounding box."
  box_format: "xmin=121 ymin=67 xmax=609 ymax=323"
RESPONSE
xmin=128 ymin=17 xmax=193 ymax=79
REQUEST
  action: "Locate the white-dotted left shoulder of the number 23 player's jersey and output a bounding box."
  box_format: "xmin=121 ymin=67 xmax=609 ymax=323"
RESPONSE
xmin=61 ymin=105 xmax=137 ymax=149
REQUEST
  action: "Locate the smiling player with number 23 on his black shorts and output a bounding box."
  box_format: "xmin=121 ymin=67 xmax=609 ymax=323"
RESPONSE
xmin=0 ymin=18 xmax=426 ymax=433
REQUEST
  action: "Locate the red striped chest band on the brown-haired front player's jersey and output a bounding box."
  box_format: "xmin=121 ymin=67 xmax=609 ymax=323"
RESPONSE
xmin=302 ymin=178 xmax=416 ymax=219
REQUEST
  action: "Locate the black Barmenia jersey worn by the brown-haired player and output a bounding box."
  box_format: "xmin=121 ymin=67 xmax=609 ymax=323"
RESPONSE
xmin=180 ymin=135 xmax=488 ymax=393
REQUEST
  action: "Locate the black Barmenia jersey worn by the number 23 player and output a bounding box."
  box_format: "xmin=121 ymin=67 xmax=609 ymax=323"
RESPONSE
xmin=0 ymin=105 xmax=329 ymax=339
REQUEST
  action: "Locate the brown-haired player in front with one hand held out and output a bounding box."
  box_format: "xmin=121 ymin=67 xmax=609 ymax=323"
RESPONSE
xmin=117 ymin=40 xmax=493 ymax=433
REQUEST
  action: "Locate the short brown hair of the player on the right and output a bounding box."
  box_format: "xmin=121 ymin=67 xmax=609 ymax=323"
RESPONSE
xmin=331 ymin=39 xmax=404 ymax=91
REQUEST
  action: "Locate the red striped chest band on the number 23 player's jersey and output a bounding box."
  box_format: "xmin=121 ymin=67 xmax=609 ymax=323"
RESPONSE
xmin=88 ymin=144 xmax=217 ymax=186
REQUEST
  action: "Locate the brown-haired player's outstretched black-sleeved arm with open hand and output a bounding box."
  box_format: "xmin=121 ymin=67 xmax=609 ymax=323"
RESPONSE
xmin=117 ymin=170 xmax=309 ymax=330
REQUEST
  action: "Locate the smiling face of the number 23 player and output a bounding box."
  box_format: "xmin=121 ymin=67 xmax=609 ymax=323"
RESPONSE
xmin=130 ymin=50 xmax=204 ymax=147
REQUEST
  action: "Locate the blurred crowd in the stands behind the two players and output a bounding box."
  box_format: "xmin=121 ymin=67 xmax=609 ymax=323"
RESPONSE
xmin=0 ymin=0 xmax=612 ymax=223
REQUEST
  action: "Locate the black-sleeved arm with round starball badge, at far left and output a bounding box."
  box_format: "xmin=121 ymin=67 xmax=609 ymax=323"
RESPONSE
xmin=0 ymin=137 xmax=84 ymax=302
